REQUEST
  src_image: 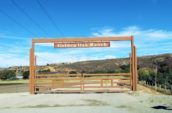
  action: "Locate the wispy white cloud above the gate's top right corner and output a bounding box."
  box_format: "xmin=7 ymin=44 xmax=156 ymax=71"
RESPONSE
xmin=92 ymin=26 xmax=172 ymax=41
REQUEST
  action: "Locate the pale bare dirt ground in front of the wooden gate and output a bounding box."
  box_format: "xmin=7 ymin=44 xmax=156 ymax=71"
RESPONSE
xmin=0 ymin=85 xmax=172 ymax=113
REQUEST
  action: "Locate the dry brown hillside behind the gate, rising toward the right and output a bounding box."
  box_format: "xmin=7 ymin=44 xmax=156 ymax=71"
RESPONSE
xmin=5 ymin=54 xmax=172 ymax=73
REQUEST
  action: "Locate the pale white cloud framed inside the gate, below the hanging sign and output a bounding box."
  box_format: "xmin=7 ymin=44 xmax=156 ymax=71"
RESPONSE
xmin=35 ymin=49 xmax=116 ymax=65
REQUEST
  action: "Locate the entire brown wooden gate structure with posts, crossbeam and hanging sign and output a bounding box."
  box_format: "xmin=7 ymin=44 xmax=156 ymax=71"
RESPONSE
xmin=29 ymin=36 xmax=137 ymax=94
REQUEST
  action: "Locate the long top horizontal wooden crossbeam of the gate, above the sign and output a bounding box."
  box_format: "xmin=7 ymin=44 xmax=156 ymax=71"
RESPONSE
xmin=32 ymin=36 xmax=133 ymax=43
